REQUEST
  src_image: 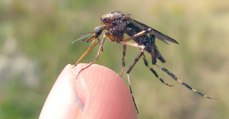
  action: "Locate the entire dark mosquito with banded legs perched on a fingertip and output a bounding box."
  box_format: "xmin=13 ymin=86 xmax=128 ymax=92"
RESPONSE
xmin=76 ymin=11 xmax=213 ymax=111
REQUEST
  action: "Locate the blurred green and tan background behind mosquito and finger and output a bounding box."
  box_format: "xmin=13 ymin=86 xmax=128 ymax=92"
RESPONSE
xmin=0 ymin=0 xmax=229 ymax=119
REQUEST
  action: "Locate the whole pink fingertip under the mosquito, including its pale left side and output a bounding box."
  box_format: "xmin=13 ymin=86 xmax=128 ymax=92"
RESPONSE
xmin=40 ymin=64 xmax=137 ymax=119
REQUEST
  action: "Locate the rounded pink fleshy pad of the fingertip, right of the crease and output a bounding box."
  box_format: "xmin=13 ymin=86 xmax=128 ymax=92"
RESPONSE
xmin=73 ymin=64 xmax=137 ymax=119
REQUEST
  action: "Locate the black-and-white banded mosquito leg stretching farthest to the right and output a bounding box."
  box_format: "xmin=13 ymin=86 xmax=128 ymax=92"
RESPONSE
xmin=156 ymin=65 xmax=215 ymax=99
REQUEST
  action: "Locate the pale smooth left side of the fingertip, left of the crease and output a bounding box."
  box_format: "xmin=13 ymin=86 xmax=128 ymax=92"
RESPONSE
xmin=39 ymin=64 xmax=80 ymax=119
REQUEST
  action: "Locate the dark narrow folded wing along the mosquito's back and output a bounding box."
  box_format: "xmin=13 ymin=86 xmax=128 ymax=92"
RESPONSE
xmin=131 ymin=19 xmax=179 ymax=44
